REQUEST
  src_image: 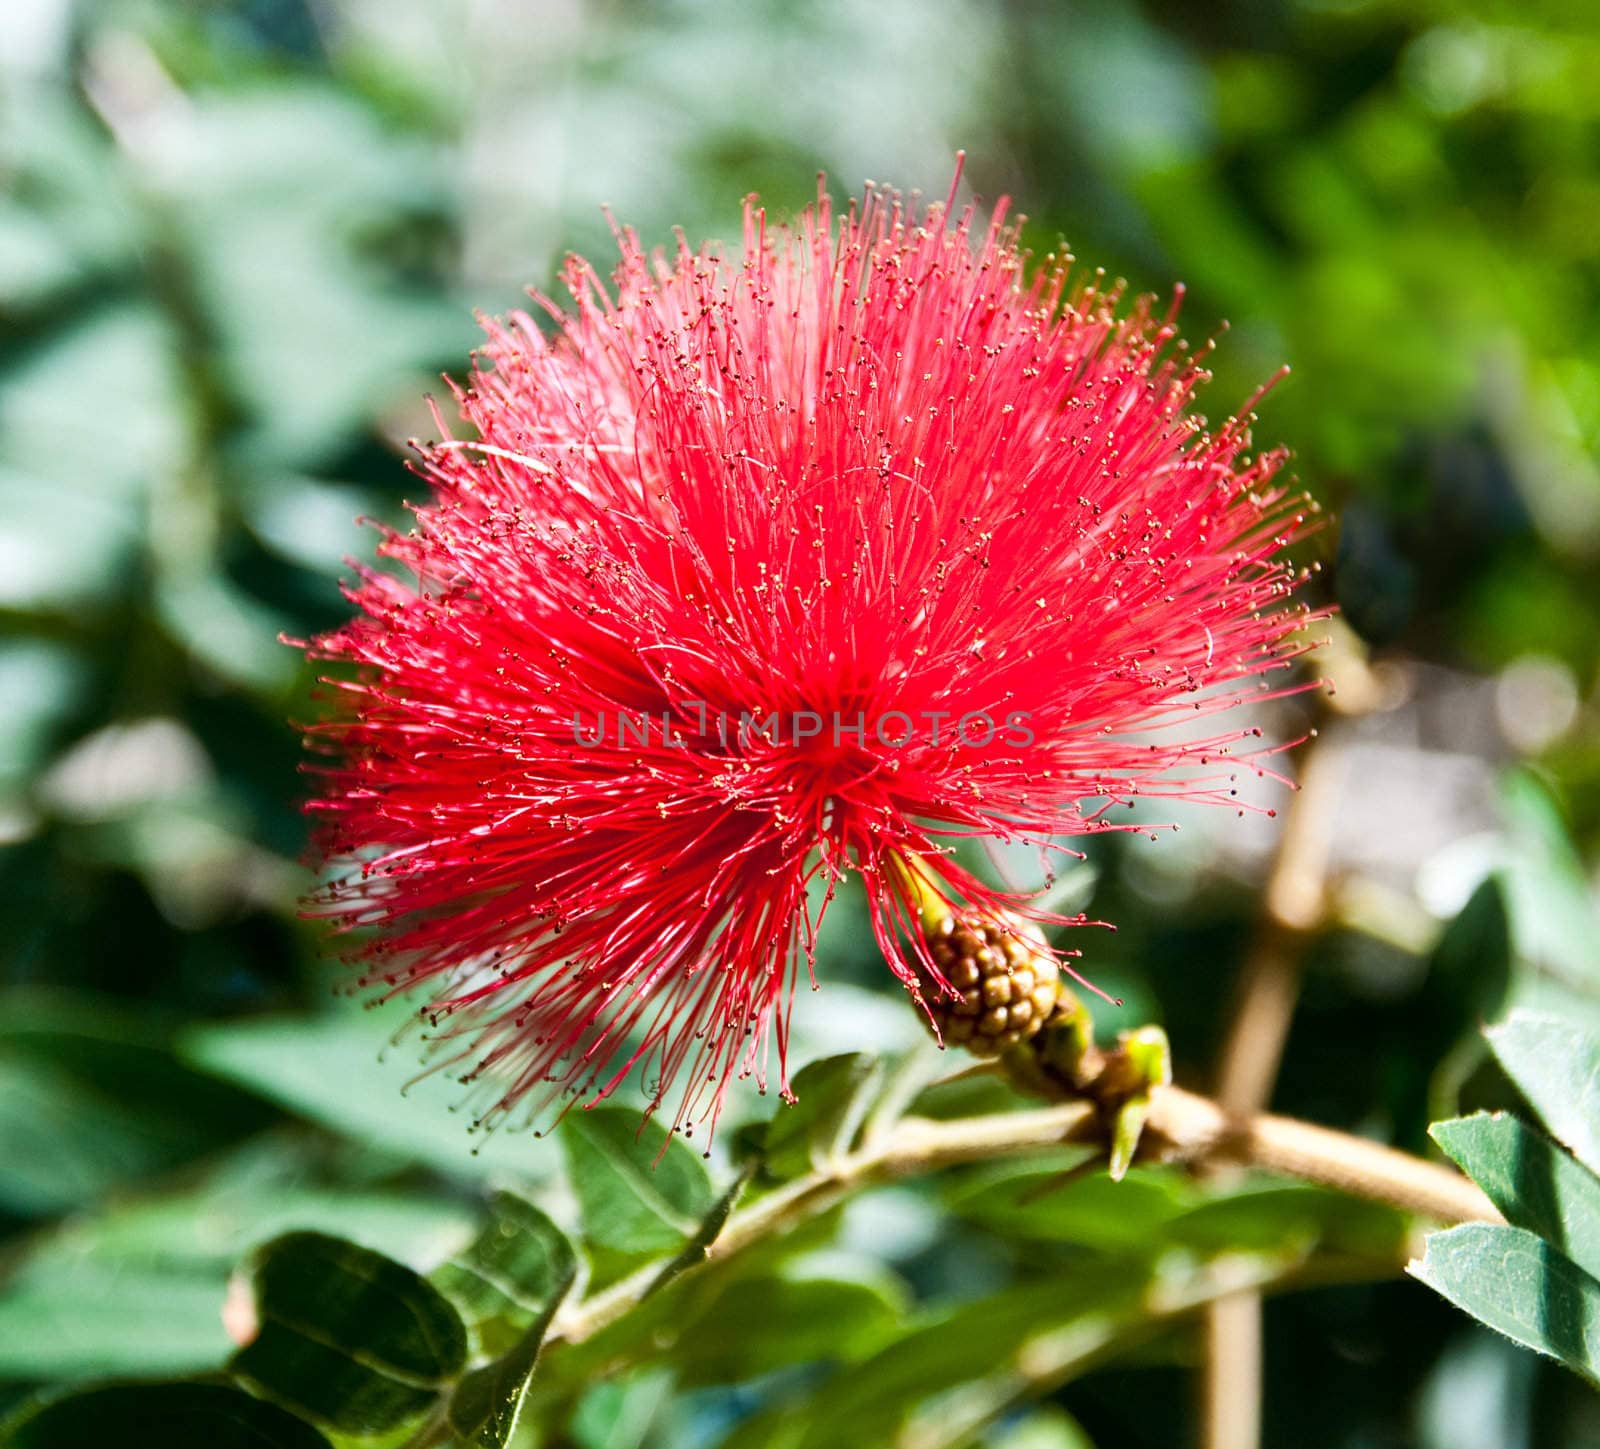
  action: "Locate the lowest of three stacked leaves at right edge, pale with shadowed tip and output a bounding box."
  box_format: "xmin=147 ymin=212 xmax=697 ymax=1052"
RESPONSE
xmin=1406 ymin=1222 xmax=1600 ymax=1388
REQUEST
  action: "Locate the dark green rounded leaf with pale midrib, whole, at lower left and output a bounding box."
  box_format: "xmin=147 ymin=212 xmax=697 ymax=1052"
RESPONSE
xmin=229 ymin=1233 xmax=467 ymax=1435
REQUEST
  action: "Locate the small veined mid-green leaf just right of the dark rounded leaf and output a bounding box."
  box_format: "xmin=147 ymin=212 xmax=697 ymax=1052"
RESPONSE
xmin=430 ymin=1192 xmax=578 ymax=1358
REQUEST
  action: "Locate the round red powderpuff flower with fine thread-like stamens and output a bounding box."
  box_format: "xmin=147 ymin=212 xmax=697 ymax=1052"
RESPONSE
xmin=294 ymin=166 xmax=1306 ymax=1131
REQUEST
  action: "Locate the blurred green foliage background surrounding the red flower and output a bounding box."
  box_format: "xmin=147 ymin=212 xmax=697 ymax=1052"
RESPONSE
xmin=0 ymin=0 xmax=1600 ymax=1449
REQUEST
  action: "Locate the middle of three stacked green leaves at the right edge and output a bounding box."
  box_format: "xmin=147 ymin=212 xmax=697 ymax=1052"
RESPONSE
xmin=1430 ymin=1112 xmax=1600 ymax=1278
